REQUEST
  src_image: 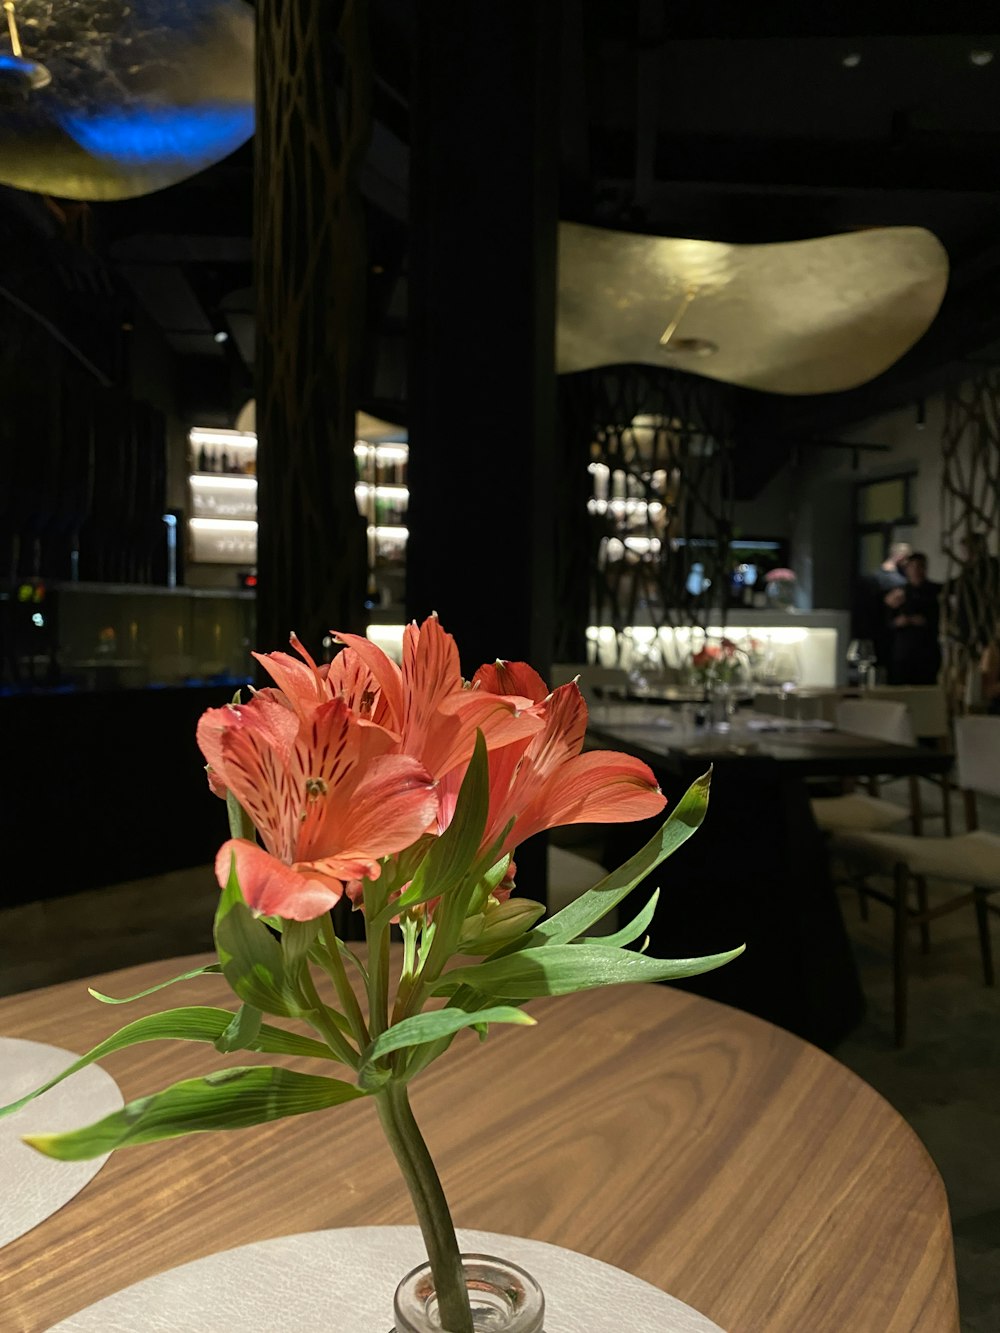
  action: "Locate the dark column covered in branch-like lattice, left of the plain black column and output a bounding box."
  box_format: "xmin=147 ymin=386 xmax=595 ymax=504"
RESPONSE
xmin=253 ymin=0 xmax=371 ymax=657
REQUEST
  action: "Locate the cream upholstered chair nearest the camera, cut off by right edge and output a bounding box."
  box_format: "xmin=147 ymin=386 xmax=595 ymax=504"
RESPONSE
xmin=835 ymin=717 xmax=1000 ymax=1046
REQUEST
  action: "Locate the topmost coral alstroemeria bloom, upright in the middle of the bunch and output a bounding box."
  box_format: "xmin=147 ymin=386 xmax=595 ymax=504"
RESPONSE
xmin=331 ymin=616 xmax=541 ymax=777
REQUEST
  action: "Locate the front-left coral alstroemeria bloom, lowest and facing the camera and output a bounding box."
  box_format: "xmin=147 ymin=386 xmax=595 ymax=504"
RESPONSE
xmin=197 ymin=687 xmax=437 ymax=921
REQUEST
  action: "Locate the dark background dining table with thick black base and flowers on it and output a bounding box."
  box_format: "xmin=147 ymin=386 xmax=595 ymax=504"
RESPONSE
xmin=587 ymin=702 xmax=952 ymax=1050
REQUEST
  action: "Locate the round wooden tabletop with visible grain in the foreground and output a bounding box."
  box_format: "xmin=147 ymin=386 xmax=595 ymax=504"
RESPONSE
xmin=0 ymin=958 xmax=957 ymax=1333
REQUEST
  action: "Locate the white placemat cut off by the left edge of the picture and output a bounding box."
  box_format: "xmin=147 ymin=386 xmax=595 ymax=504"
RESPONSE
xmin=0 ymin=1037 xmax=124 ymax=1247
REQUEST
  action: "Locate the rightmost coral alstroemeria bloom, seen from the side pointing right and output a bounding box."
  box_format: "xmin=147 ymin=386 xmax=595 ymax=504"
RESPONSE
xmin=458 ymin=663 xmax=667 ymax=856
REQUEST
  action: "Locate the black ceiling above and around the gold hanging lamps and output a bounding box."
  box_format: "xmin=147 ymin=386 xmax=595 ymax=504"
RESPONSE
xmin=7 ymin=0 xmax=1000 ymax=487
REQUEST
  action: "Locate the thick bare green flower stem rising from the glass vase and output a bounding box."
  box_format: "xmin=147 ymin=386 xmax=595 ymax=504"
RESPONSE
xmin=375 ymin=1082 xmax=473 ymax=1333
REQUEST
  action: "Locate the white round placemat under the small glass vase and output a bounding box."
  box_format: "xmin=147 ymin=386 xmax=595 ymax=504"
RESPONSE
xmin=49 ymin=1226 xmax=721 ymax=1333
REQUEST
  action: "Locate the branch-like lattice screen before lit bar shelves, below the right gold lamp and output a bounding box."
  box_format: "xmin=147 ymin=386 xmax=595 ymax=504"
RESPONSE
xmin=557 ymin=367 xmax=733 ymax=660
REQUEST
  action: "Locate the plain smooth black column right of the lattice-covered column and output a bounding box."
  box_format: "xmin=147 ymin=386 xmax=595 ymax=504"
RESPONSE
xmin=407 ymin=0 xmax=560 ymax=674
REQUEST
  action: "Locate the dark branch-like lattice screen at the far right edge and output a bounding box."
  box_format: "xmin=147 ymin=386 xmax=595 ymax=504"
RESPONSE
xmin=941 ymin=368 xmax=1000 ymax=712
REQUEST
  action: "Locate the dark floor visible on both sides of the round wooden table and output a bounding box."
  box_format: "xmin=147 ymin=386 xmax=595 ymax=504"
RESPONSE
xmin=0 ymin=790 xmax=1000 ymax=1333
